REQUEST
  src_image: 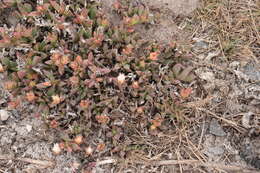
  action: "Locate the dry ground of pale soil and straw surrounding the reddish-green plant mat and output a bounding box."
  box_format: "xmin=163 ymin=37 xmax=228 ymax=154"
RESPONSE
xmin=0 ymin=0 xmax=260 ymax=173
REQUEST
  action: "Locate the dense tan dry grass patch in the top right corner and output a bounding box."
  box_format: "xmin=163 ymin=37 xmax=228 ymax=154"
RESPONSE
xmin=190 ymin=0 xmax=260 ymax=62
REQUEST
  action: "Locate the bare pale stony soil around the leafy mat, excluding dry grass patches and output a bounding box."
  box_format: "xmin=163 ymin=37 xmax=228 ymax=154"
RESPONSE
xmin=0 ymin=0 xmax=260 ymax=173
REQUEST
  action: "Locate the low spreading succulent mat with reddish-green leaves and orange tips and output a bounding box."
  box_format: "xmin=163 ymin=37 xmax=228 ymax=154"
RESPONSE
xmin=0 ymin=0 xmax=195 ymax=171
